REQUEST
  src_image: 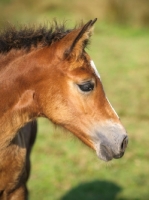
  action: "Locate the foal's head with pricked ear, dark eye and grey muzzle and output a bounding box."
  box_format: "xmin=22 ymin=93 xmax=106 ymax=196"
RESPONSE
xmin=33 ymin=19 xmax=128 ymax=161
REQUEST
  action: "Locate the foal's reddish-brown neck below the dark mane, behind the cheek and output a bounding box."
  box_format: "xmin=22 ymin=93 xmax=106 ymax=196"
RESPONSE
xmin=0 ymin=51 xmax=39 ymax=148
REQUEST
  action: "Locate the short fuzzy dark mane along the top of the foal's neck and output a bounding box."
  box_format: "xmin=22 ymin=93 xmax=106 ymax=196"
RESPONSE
xmin=0 ymin=21 xmax=72 ymax=53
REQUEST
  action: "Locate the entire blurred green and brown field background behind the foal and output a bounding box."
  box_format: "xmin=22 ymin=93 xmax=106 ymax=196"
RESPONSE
xmin=0 ymin=0 xmax=149 ymax=200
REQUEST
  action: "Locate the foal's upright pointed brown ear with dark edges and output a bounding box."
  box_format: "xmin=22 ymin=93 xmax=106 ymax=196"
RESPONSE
xmin=62 ymin=18 xmax=97 ymax=60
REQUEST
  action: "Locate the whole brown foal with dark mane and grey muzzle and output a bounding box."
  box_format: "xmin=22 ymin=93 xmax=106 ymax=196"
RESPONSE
xmin=0 ymin=19 xmax=128 ymax=200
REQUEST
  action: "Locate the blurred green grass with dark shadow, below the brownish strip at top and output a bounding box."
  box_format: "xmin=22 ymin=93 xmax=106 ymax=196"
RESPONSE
xmin=29 ymin=23 xmax=149 ymax=200
